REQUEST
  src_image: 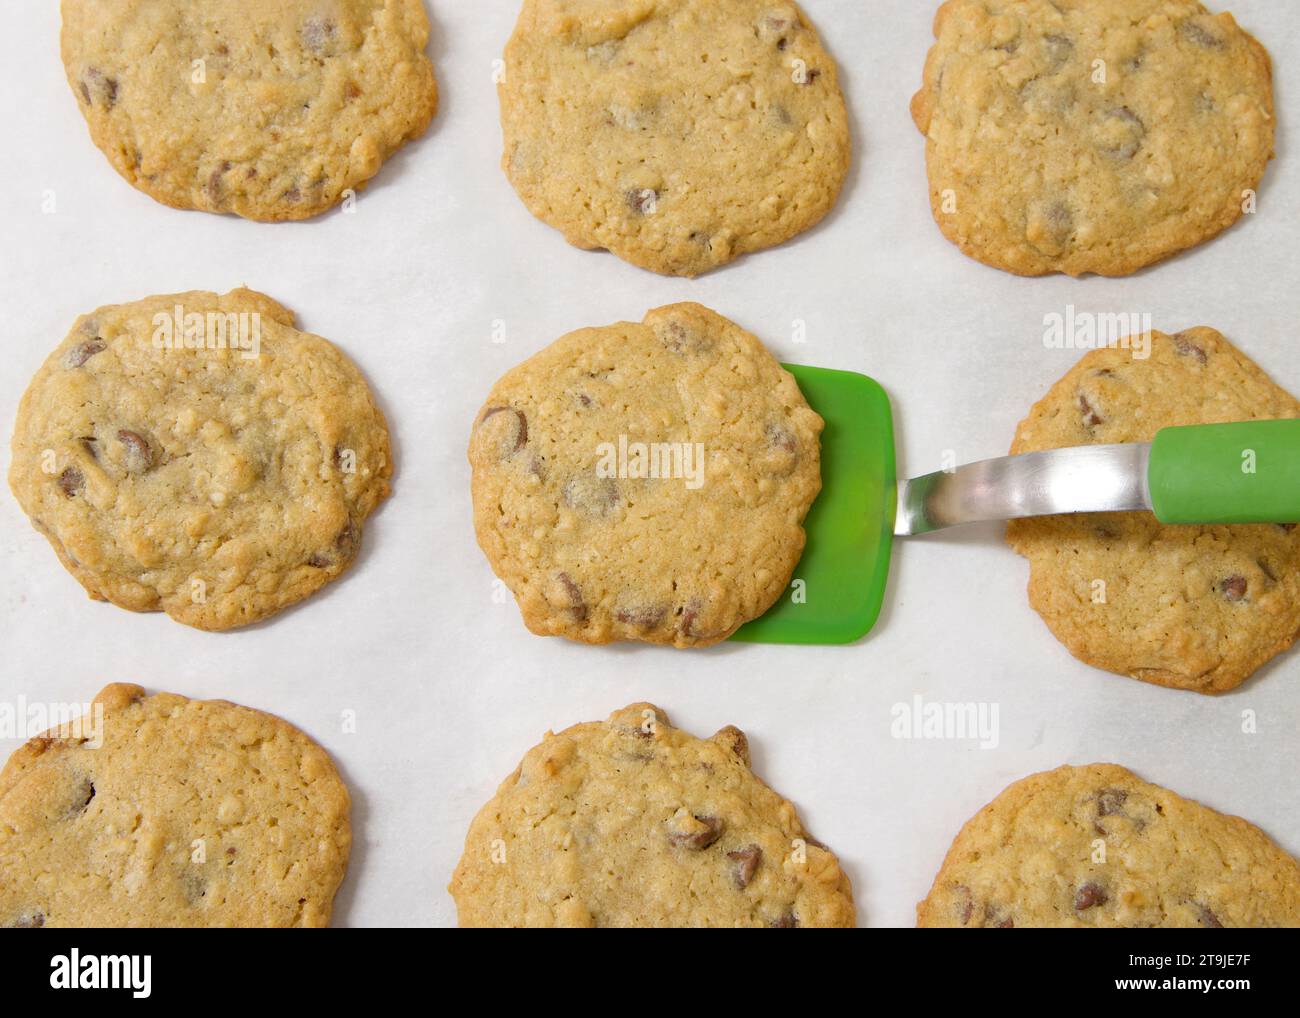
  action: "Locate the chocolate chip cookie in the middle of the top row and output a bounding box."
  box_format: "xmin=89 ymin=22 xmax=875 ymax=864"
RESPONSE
xmin=499 ymin=0 xmax=850 ymax=276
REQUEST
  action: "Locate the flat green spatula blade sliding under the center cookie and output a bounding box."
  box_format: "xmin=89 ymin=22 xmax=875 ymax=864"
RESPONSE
xmin=732 ymin=364 xmax=898 ymax=645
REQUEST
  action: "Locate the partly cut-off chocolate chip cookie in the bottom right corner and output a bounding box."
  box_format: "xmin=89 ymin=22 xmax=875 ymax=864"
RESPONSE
xmin=917 ymin=763 xmax=1300 ymax=930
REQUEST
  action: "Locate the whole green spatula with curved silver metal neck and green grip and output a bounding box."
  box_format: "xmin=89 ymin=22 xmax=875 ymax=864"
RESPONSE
xmin=732 ymin=364 xmax=1300 ymax=645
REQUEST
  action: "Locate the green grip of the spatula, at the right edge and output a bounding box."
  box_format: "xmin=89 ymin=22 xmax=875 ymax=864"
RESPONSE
xmin=1147 ymin=420 xmax=1300 ymax=524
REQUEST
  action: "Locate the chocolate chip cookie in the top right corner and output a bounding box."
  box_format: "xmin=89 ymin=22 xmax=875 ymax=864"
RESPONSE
xmin=911 ymin=0 xmax=1274 ymax=276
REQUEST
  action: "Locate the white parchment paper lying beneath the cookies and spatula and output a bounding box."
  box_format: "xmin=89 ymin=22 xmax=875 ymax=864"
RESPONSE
xmin=0 ymin=0 xmax=1300 ymax=926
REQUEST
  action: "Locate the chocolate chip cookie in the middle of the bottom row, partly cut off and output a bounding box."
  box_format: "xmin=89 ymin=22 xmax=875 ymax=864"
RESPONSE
xmin=450 ymin=703 xmax=855 ymax=930
